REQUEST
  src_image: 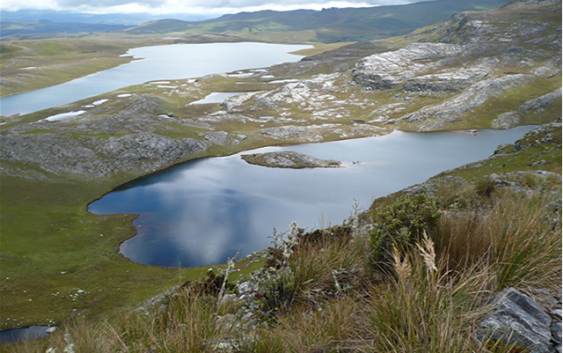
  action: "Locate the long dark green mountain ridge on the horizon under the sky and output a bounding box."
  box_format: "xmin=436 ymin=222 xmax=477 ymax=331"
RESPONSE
xmin=128 ymin=0 xmax=507 ymax=43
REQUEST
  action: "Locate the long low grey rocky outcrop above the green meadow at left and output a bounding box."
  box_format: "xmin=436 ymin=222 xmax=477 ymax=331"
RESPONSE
xmin=0 ymin=132 xmax=211 ymax=178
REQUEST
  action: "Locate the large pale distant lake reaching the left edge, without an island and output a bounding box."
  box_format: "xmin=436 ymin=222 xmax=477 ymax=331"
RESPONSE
xmin=0 ymin=43 xmax=311 ymax=115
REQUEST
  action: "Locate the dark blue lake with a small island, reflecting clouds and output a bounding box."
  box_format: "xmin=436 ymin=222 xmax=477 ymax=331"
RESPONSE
xmin=89 ymin=126 xmax=532 ymax=267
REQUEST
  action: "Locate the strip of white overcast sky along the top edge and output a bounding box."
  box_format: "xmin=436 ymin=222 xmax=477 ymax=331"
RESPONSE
xmin=0 ymin=0 xmax=430 ymax=15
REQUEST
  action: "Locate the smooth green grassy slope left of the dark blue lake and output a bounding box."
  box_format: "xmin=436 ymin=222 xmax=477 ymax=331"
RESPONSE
xmin=0 ymin=177 xmax=200 ymax=329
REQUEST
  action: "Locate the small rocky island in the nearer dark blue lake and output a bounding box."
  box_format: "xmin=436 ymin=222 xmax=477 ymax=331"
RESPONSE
xmin=241 ymin=151 xmax=341 ymax=169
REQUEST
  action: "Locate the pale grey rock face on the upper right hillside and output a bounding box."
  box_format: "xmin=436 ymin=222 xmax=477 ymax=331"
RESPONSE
xmin=346 ymin=1 xmax=561 ymax=131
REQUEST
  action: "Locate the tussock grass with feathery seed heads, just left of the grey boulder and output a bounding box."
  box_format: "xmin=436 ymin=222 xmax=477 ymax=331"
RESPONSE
xmin=363 ymin=238 xmax=489 ymax=353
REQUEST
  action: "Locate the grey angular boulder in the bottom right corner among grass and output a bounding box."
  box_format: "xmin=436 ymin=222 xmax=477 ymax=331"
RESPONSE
xmin=478 ymin=288 xmax=551 ymax=353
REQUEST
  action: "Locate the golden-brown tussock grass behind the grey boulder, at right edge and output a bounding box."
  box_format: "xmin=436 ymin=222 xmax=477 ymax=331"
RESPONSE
xmin=436 ymin=187 xmax=562 ymax=290
